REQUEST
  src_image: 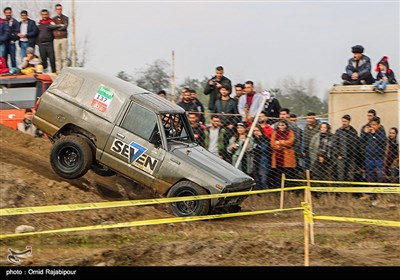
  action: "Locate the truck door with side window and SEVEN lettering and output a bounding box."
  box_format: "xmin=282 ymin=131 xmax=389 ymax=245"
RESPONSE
xmin=100 ymin=102 xmax=165 ymax=186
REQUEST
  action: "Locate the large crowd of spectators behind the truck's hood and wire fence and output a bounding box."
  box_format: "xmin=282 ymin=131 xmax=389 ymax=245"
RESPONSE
xmin=165 ymin=63 xmax=399 ymax=189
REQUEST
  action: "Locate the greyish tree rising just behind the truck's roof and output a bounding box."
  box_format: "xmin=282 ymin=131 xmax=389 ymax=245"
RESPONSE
xmin=133 ymin=59 xmax=171 ymax=93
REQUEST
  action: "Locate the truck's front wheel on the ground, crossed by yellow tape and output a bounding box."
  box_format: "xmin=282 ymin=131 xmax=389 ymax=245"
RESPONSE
xmin=168 ymin=181 xmax=210 ymax=217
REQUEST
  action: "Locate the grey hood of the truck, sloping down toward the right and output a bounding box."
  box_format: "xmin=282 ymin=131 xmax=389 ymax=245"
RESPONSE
xmin=171 ymin=146 xmax=254 ymax=186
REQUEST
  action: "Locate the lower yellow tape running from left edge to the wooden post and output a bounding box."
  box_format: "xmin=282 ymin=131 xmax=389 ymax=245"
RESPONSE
xmin=0 ymin=207 xmax=303 ymax=239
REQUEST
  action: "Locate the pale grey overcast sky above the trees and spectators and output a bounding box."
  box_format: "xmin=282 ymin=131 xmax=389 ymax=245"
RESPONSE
xmin=16 ymin=0 xmax=400 ymax=96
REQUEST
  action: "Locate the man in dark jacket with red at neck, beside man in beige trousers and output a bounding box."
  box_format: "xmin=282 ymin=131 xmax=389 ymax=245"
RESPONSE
xmin=37 ymin=9 xmax=56 ymax=73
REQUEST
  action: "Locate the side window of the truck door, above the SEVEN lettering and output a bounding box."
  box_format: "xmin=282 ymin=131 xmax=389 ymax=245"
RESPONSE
xmin=121 ymin=103 xmax=157 ymax=140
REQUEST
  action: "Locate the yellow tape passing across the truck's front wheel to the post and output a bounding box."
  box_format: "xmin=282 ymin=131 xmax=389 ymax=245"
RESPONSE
xmin=0 ymin=187 xmax=304 ymax=216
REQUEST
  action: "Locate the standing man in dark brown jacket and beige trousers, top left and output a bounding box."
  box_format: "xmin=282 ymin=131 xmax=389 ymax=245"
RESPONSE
xmin=51 ymin=4 xmax=68 ymax=73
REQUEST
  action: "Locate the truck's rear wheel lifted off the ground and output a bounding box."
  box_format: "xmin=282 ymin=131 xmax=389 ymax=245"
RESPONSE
xmin=50 ymin=135 xmax=92 ymax=179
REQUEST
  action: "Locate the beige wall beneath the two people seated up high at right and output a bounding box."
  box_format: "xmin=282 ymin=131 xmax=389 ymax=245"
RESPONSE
xmin=329 ymin=85 xmax=400 ymax=134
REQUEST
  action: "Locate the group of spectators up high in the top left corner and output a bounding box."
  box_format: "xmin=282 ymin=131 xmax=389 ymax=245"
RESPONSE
xmin=0 ymin=4 xmax=69 ymax=74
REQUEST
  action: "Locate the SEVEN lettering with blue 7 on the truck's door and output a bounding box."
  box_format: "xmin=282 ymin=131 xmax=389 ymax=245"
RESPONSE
xmin=111 ymin=139 xmax=158 ymax=174
